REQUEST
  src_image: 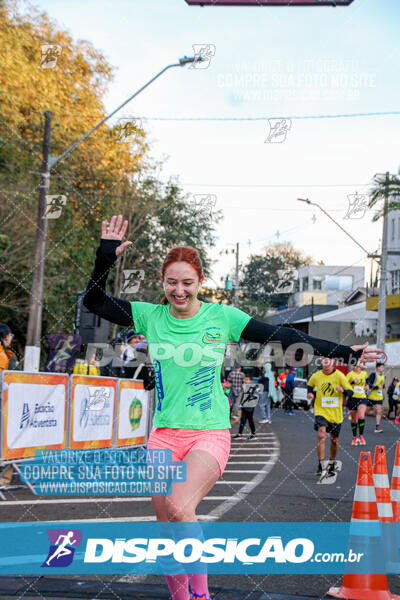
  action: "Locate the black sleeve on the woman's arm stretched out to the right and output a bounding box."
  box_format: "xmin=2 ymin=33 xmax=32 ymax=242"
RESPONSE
xmin=241 ymin=318 xmax=362 ymax=365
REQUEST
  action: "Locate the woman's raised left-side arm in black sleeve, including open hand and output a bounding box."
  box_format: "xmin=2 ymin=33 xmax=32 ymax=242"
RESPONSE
xmin=83 ymin=215 xmax=133 ymax=327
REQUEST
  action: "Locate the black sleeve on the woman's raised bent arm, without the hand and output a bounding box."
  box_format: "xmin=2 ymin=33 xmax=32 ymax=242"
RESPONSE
xmin=83 ymin=240 xmax=133 ymax=327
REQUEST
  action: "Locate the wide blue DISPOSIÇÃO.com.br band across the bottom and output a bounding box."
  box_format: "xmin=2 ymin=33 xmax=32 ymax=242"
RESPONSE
xmin=0 ymin=521 xmax=400 ymax=575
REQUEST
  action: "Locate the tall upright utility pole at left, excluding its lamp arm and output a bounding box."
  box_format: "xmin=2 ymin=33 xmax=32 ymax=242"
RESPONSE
xmin=24 ymin=111 xmax=52 ymax=371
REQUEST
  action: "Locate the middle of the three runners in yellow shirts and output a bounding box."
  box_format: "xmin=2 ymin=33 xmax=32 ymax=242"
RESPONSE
xmin=346 ymin=365 xmax=369 ymax=446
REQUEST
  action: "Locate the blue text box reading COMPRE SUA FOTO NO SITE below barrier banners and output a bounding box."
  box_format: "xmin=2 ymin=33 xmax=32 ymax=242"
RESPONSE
xmin=21 ymin=448 xmax=186 ymax=496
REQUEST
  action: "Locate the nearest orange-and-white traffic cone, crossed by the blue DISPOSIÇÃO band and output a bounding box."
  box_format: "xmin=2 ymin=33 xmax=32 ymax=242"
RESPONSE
xmin=328 ymin=452 xmax=400 ymax=600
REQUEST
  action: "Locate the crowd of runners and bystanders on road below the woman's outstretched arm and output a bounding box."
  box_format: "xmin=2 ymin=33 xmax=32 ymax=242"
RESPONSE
xmin=222 ymin=358 xmax=400 ymax=477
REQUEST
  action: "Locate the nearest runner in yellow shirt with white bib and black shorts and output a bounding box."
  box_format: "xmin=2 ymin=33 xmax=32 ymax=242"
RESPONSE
xmin=307 ymin=358 xmax=353 ymax=477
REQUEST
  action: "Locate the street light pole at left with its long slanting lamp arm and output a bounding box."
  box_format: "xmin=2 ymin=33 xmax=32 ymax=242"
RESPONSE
xmin=24 ymin=55 xmax=200 ymax=371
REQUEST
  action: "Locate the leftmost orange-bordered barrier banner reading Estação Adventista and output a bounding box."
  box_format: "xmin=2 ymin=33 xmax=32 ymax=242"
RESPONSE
xmin=1 ymin=371 xmax=68 ymax=460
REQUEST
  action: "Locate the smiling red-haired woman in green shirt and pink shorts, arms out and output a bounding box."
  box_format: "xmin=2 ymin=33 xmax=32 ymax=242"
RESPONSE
xmin=83 ymin=215 xmax=380 ymax=600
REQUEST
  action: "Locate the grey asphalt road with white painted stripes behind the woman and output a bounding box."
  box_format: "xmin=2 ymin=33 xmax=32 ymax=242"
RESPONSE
xmin=0 ymin=409 xmax=400 ymax=600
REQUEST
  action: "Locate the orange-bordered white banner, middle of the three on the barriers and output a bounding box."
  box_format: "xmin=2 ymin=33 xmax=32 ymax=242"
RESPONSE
xmin=69 ymin=375 xmax=117 ymax=449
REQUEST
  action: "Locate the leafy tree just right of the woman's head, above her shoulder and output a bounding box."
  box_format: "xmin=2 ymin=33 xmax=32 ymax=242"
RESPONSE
xmin=240 ymin=242 xmax=313 ymax=317
